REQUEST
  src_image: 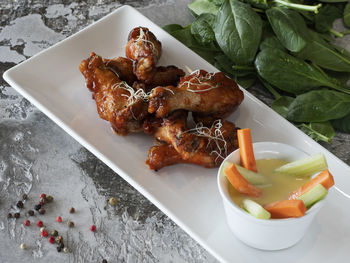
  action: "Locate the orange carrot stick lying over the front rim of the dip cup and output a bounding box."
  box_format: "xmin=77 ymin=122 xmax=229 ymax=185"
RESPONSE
xmin=264 ymin=200 xmax=306 ymax=218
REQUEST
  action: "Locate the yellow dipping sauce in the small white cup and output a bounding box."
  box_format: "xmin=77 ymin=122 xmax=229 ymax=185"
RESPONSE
xmin=228 ymin=159 xmax=310 ymax=206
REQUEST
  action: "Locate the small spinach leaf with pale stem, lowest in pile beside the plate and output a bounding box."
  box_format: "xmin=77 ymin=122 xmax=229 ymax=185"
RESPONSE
xmin=299 ymin=121 xmax=335 ymax=142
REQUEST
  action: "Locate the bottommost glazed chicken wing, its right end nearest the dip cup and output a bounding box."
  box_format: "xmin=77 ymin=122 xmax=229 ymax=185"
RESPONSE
xmin=146 ymin=121 xmax=238 ymax=170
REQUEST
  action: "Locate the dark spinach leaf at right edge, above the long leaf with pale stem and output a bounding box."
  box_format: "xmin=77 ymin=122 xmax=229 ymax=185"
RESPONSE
xmin=297 ymin=30 xmax=350 ymax=72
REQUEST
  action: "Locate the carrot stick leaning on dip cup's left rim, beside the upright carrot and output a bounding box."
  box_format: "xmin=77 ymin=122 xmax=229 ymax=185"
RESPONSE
xmin=225 ymin=163 xmax=262 ymax=197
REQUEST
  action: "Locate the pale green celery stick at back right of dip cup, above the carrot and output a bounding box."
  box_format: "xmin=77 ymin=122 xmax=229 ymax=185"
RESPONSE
xmin=275 ymin=153 xmax=328 ymax=176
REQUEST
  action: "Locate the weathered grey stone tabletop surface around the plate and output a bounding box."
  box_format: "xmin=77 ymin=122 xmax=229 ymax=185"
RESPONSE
xmin=0 ymin=0 xmax=350 ymax=262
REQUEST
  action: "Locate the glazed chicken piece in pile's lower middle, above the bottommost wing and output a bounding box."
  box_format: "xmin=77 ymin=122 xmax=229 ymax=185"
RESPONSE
xmin=143 ymin=110 xmax=201 ymax=159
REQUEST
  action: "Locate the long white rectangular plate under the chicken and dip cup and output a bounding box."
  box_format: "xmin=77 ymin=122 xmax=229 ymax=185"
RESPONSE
xmin=4 ymin=6 xmax=350 ymax=263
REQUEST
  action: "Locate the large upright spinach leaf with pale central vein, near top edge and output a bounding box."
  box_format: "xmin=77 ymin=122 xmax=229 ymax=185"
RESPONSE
xmin=214 ymin=0 xmax=262 ymax=65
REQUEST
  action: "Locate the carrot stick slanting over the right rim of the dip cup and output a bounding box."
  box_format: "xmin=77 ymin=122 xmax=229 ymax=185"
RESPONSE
xmin=288 ymin=169 xmax=334 ymax=200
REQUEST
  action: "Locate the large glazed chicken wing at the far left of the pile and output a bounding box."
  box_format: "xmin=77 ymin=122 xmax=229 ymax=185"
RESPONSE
xmin=79 ymin=53 xmax=147 ymax=135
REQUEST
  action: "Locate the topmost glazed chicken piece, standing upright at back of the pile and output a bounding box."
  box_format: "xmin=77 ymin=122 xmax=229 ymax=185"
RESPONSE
xmin=125 ymin=27 xmax=162 ymax=83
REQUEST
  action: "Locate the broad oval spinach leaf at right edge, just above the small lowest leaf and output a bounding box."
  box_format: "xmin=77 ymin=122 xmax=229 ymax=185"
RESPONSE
xmin=287 ymin=89 xmax=350 ymax=122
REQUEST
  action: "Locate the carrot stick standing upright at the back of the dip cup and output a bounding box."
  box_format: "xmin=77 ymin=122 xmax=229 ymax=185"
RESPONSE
xmin=237 ymin=128 xmax=258 ymax=172
